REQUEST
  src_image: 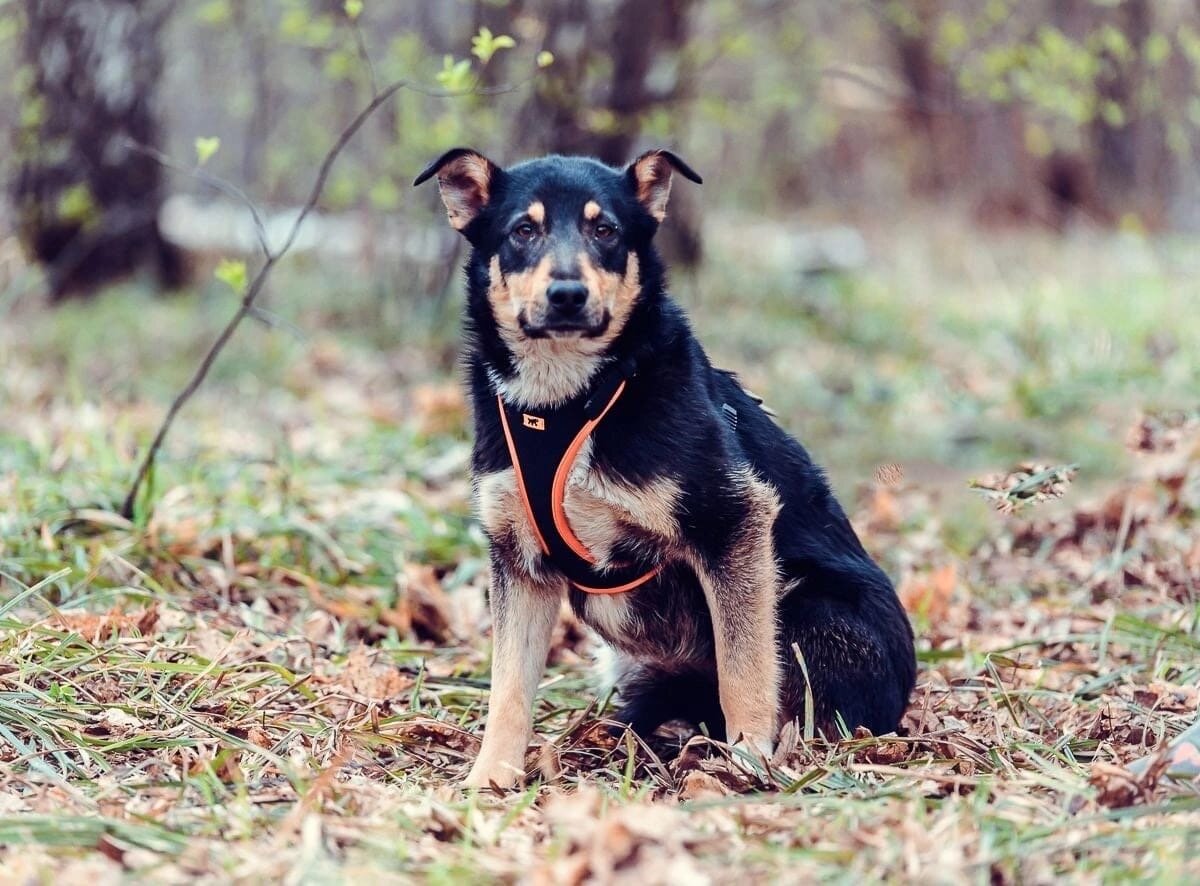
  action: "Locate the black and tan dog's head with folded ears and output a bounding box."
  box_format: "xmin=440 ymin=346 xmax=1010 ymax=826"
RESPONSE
xmin=413 ymin=148 xmax=701 ymax=351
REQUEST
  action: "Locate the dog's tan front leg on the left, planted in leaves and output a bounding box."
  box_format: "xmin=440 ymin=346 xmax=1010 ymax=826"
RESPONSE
xmin=464 ymin=553 xmax=559 ymax=788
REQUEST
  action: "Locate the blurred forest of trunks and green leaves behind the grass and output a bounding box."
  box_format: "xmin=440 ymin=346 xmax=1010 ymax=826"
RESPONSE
xmin=11 ymin=0 xmax=1200 ymax=291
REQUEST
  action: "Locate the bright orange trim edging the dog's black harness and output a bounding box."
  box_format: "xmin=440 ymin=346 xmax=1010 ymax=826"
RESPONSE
xmin=496 ymin=381 xmax=662 ymax=594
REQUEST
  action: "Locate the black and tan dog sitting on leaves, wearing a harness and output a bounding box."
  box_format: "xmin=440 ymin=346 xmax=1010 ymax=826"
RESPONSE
xmin=414 ymin=149 xmax=916 ymax=786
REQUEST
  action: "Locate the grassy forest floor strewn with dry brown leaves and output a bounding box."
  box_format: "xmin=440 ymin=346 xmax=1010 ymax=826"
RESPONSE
xmin=0 ymin=219 xmax=1200 ymax=884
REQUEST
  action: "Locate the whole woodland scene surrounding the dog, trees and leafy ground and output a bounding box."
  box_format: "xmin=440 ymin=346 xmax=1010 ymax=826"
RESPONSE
xmin=0 ymin=0 xmax=1200 ymax=882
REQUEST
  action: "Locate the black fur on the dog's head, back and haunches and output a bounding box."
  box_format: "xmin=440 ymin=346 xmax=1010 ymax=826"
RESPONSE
xmin=425 ymin=155 xmax=916 ymax=737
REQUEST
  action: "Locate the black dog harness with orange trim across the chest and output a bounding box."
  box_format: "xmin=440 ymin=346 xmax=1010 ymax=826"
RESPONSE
xmin=496 ymin=358 xmax=661 ymax=594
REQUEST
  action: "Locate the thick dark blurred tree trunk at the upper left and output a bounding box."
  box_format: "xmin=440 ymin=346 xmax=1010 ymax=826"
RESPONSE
xmin=12 ymin=0 xmax=181 ymax=300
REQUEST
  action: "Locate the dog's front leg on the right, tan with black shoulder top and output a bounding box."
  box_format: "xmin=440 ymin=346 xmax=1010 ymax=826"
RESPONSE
xmin=694 ymin=472 xmax=780 ymax=758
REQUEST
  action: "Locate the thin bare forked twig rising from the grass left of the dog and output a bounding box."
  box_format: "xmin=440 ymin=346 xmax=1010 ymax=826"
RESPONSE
xmin=121 ymin=80 xmax=409 ymax=519
